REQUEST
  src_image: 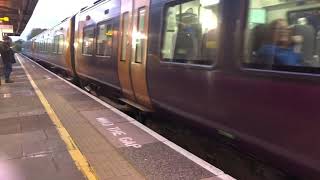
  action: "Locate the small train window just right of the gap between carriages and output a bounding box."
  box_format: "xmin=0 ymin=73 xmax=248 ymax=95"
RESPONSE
xmin=82 ymin=26 xmax=94 ymax=55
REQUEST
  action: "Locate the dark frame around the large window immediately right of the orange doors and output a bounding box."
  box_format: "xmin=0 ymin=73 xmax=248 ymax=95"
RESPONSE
xmin=158 ymin=0 xmax=221 ymax=70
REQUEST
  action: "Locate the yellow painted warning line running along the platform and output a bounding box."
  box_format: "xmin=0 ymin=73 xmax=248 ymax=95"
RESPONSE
xmin=17 ymin=56 xmax=98 ymax=180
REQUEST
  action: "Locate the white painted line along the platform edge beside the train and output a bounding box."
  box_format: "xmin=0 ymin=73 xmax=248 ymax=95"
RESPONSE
xmin=19 ymin=54 xmax=235 ymax=180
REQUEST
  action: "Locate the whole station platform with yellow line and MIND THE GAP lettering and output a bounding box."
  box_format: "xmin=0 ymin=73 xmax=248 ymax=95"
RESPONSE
xmin=0 ymin=54 xmax=234 ymax=180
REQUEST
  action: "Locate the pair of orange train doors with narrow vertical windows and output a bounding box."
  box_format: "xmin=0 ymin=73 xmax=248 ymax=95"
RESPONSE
xmin=118 ymin=0 xmax=151 ymax=108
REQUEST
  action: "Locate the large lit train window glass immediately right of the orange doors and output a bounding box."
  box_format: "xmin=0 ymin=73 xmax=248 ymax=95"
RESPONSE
xmin=161 ymin=0 xmax=220 ymax=65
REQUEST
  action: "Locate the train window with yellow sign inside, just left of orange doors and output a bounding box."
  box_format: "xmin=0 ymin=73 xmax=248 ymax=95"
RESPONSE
xmin=97 ymin=21 xmax=113 ymax=56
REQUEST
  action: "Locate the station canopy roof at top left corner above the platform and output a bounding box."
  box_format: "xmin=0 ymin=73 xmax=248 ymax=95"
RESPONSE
xmin=0 ymin=0 xmax=38 ymax=36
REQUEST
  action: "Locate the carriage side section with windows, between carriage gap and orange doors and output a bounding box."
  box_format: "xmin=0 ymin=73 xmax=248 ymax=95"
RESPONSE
xmin=75 ymin=0 xmax=120 ymax=94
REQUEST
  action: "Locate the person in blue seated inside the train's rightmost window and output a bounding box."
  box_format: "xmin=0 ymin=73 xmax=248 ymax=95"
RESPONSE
xmin=257 ymin=19 xmax=302 ymax=66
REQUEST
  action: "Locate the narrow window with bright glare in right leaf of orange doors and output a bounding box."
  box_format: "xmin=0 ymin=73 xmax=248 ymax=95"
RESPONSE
xmin=133 ymin=8 xmax=146 ymax=63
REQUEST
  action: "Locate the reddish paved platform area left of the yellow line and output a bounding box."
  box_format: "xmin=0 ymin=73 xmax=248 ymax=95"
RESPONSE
xmin=0 ymin=60 xmax=84 ymax=180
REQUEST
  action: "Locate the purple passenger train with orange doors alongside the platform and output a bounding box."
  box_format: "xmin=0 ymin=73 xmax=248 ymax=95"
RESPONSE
xmin=24 ymin=0 xmax=320 ymax=179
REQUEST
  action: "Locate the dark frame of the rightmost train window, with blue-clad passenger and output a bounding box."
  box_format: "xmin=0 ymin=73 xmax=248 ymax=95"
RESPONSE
xmin=237 ymin=0 xmax=320 ymax=75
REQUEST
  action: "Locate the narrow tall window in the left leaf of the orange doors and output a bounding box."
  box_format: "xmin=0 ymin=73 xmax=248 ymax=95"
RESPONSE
xmin=120 ymin=12 xmax=129 ymax=61
